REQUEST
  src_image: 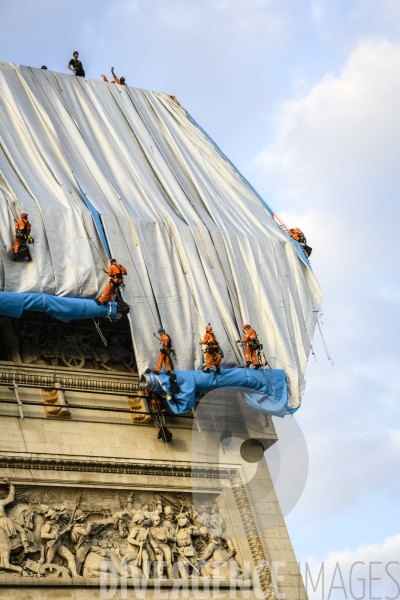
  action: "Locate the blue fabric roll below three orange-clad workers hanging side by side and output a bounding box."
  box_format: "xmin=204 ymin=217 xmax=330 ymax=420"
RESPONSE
xmin=148 ymin=367 xmax=288 ymax=417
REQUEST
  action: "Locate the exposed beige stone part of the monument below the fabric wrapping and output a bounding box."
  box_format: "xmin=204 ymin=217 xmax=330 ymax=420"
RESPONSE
xmin=0 ymin=313 xmax=306 ymax=600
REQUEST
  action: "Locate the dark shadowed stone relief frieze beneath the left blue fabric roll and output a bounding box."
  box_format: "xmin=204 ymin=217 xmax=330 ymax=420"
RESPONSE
xmin=13 ymin=321 xmax=137 ymax=373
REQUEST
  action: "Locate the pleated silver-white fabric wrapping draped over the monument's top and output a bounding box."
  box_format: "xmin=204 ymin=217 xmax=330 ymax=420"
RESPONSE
xmin=0 ymin=63 xmax=322 ymax=408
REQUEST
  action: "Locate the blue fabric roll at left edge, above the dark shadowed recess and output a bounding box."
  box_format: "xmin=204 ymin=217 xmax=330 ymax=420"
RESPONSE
xmin=0 ymin=292 xmax=118 ymax=323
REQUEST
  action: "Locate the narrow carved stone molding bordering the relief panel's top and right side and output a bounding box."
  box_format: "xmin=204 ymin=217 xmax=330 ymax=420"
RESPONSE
xmin=0 ymin=455 xmax=276 ymax=598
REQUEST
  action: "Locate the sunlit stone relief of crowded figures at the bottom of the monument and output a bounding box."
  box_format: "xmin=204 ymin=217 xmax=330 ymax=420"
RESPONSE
xmin=0 ymin=479 xmax=249 ymax=580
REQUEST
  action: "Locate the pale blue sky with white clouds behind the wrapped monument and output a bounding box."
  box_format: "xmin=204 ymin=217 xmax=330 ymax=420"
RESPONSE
xmin=0 ymin=0 xmax=400 ymax=600
